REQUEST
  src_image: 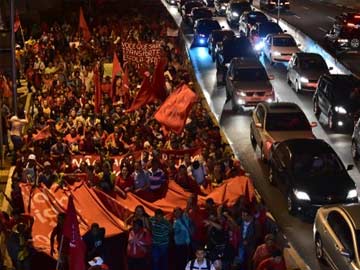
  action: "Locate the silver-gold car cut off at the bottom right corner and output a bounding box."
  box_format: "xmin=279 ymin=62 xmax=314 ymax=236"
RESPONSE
xmin=313 ymin=204 xmax=360 ymax=270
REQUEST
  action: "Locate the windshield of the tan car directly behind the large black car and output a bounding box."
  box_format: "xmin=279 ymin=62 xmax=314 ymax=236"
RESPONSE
xmin=266 ymin=112 xmax=311 ymax=131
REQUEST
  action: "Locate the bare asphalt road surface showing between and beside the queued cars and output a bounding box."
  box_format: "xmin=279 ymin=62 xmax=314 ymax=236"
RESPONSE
xmin=164 ymin=0 xmax=360 ymax=270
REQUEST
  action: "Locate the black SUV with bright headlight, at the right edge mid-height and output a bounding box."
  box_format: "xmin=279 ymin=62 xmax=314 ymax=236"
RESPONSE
xmin=313 ymin=74 xmax=360 ymax=129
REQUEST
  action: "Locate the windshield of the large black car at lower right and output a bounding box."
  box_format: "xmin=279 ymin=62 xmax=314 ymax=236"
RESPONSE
xmin=292 ymin=151 xmax=344 ymax=176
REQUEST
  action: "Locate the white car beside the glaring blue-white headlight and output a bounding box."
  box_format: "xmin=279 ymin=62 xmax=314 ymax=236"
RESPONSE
xmin=263 ymin=34 xmax=300 ymax=64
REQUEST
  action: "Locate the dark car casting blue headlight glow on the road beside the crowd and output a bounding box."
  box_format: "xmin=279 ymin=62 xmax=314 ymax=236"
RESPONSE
xmin=191 ymin=19 xmax=222 ymax=47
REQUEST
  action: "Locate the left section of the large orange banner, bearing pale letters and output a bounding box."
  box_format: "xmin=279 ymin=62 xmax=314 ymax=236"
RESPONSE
xmin=21 ymin=183 xmax=125 ymax=254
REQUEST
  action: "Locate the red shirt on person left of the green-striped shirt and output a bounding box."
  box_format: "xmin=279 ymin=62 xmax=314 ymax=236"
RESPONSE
xmin=127 ymin=229 xmax=151 ymax=258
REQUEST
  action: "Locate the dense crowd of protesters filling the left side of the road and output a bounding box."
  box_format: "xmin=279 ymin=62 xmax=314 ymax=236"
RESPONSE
xmin=0 ymin=2 xmax=286 ymax=270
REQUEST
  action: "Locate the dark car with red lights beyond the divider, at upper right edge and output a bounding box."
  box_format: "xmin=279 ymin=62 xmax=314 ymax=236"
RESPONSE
xmin=325 ymin=13 xmax=360 ymax=50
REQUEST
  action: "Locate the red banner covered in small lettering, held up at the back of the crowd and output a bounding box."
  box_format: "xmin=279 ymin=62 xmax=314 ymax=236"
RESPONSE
xmin=121 ymin=42 xmax=161 ymax=67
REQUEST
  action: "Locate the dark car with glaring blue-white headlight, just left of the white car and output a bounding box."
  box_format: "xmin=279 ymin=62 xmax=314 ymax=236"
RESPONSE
xmin=249 ymin=21 xmax=284 ymax=52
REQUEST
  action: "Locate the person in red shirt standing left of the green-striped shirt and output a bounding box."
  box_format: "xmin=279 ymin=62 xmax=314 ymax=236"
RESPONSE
xmin=127 ymin=219 xmax=151 ymax=270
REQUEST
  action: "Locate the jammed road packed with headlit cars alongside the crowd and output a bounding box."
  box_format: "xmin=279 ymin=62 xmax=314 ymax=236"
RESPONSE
xmin=166 ymin=0 xmax=360 ymax=270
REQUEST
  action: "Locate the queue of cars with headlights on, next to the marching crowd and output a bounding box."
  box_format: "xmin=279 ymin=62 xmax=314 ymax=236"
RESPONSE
xmin=167 ymin=0 xmax=360 ymax=269
